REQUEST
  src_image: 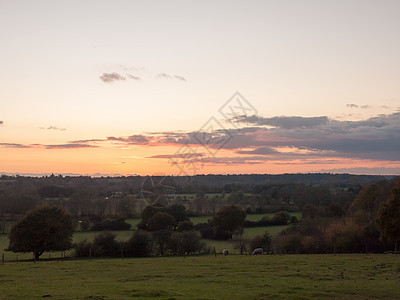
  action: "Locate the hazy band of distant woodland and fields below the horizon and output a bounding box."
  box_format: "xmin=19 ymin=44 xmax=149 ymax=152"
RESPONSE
xmin=0 ymin=174 xmax=393 ymax=220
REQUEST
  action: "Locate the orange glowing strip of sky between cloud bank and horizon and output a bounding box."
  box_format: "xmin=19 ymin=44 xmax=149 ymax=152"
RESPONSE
xmin=0 ymin=145 xmax=400 ymax=176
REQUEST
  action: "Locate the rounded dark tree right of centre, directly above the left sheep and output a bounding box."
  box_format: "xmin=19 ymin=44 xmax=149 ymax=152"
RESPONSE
xmin=213 ymin=205 xmax=246 ymax=239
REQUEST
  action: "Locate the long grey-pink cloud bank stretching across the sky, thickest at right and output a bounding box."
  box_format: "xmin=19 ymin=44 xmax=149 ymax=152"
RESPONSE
xmin=25 ymin=112 xmax=400 ymax=164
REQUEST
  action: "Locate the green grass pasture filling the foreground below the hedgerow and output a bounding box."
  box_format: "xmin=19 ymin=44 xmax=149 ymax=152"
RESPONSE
xmin=0 ymin=255 xmax=400 ymax=299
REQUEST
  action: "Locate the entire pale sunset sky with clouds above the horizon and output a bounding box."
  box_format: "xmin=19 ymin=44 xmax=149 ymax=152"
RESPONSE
xmin=0 ymin=0 xmax=400 ymax=176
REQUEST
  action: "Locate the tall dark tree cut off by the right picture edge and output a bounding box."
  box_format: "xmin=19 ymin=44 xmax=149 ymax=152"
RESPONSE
xmin=376 ymin=179 xmax=400 ymax=251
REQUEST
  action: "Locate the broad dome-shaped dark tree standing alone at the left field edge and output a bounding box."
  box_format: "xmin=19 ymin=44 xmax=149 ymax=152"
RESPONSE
xmin=8 ymin=206 xmax=74 ymax=259
